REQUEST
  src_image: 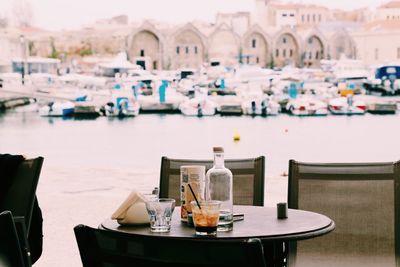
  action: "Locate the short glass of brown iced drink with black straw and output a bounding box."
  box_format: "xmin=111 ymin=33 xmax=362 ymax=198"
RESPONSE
xmin=191 ymin=200 xmax=221 ymax=235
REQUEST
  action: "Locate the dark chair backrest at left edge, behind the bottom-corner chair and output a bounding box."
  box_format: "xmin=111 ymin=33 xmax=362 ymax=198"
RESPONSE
xmin=0 ymin=157 xmax=43 ymax=232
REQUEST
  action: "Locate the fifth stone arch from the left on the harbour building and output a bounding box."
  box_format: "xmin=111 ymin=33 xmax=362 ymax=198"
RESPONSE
xmin=274 ymin=33 xmax=299 ymax=67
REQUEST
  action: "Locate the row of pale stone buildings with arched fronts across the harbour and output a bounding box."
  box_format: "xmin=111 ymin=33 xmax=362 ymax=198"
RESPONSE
xmin=10 ymin=0 xmax=400 ymax=70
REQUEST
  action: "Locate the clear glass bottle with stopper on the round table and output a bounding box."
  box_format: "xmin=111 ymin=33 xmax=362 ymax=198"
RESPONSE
xmin=205 ymin=147 xmax=233 ymax=232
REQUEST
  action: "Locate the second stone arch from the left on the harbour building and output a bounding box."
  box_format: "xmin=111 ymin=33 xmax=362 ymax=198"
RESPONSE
xmin=171 ymin=29 xmax=205 ymax=69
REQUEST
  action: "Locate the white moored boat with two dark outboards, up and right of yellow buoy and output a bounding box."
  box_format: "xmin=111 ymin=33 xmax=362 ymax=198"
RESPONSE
xmin=242 ymin=97 xmax=280 ymax=116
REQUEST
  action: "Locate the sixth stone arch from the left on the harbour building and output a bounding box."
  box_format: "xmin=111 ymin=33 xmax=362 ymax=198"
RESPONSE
xmin=301 ymin=35 xmax=325 ymax=68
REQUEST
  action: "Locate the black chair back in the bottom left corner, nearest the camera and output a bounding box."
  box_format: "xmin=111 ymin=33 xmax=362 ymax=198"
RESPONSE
xmin=0 ymin=211 xmax=25 ymax=267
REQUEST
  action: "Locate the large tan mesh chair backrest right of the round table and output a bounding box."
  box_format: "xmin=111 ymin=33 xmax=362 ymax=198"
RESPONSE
xmin=288 ymin=160 xmax=400 ymax=267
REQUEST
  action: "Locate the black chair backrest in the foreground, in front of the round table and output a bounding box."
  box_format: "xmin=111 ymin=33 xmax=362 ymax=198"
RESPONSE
xmin=74 ymin=225 xmax=265 ymax=267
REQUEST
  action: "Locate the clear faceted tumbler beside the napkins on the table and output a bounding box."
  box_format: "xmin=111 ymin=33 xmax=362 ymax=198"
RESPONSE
xmin=146 ymin=198 xmax=175 ymax=233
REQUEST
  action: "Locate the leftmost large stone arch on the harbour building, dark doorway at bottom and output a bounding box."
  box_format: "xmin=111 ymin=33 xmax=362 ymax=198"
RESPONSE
xmin=129 ymin=30 xmax=162 ymax=69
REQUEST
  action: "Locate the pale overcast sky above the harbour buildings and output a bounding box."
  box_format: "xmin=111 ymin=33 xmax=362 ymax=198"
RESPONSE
xmin=0 ymin=0 xmax=387 ymax=30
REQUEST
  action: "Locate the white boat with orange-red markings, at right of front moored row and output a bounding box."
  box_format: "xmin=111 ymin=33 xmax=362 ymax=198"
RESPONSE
xmin=328 ymin=94 xmax=367 ymax=115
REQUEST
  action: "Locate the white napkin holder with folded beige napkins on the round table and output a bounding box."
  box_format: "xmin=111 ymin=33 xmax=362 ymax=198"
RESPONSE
xmin=111 ymin=191 xmax=150 ymax=225
